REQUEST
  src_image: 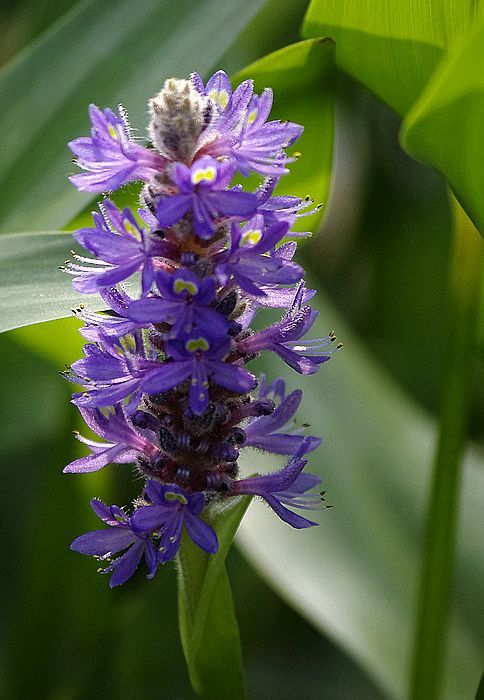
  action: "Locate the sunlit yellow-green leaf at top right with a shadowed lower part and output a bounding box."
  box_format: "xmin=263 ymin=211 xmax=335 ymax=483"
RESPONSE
xmin=303 ymin=0 xmax=476 ymax=114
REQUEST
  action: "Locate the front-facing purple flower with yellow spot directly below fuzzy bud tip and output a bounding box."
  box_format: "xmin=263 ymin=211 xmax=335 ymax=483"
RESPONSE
xmin=156 ymin=156 xmax=257 ymax=239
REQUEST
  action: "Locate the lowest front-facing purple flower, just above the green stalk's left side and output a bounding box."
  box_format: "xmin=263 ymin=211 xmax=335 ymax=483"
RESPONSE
xmin=131 ymin=479 xmax=218 ymax=564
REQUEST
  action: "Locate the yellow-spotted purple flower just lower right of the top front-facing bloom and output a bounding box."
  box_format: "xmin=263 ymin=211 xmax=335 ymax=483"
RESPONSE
xmin=213 ymin=214 xmax=304 ymax=298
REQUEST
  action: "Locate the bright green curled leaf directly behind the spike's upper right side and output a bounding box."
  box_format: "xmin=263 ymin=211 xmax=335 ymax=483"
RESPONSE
xmin=235 ymin=39 xmax=334 ymax=231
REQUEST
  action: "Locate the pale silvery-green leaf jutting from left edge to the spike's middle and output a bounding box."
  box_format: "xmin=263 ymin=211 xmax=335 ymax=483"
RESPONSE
xmin=0 ymin=233 xmax=106 ymax=332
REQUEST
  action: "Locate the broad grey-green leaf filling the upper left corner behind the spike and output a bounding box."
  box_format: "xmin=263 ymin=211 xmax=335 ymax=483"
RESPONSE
xmin=0 ymin=0 xmax=264 ymax=231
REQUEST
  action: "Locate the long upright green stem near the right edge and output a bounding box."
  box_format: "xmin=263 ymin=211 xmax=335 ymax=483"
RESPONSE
xmin=409 ymin=199 xmax=484 ymax=700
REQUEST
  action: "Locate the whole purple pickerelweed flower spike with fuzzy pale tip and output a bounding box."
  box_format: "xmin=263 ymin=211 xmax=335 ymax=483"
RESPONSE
xmin=64 ymin=71 xmax=339 ymax=586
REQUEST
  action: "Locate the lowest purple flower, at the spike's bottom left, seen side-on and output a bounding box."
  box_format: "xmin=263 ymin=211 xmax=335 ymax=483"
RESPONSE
xmin=71 ymin=498 xmax=158 ymax=588
